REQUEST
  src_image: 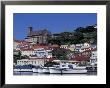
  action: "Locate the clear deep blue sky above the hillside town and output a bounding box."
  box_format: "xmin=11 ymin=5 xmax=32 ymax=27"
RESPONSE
xmin=13 ymin=13 xmax=97 ymax=40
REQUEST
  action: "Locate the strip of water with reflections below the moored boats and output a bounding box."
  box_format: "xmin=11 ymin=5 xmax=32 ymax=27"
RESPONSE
xmin=13 ymin=72 xmax=97 ymax=76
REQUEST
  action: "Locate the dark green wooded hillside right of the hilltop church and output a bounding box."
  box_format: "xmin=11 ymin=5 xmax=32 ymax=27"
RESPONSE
xmin=48 ymin=25 xmax=97 ymax=45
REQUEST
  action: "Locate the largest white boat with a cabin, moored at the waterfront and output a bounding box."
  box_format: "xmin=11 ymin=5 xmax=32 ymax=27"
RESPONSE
xmin=49 ymin=63 xmax=87 ymax=74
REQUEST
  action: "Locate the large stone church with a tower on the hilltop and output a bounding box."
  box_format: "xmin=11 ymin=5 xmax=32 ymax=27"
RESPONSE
xmin=25 ymin=27 xmax=51 ymax=44
